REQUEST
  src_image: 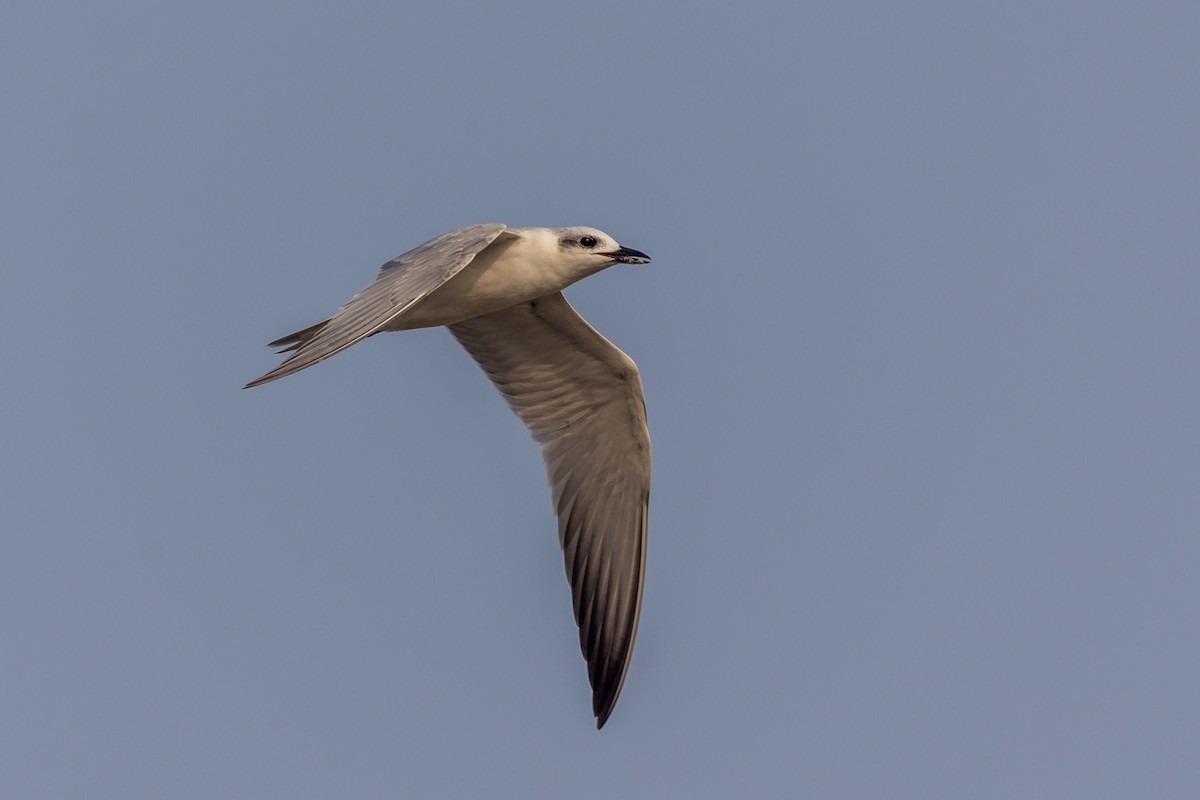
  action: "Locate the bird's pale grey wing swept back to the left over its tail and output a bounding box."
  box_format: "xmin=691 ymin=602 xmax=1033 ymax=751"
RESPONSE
xmin=246 ymin=223 xmax=505 ymax=389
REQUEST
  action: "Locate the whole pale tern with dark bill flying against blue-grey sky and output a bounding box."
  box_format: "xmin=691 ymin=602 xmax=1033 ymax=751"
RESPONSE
xmin=247 ymin=224 xmax=650 ymax=727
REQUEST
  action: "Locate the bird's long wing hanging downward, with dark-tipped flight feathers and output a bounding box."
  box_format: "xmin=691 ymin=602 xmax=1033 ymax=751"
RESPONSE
xmin=449 ymin=294 xmax=650 ymax=727
